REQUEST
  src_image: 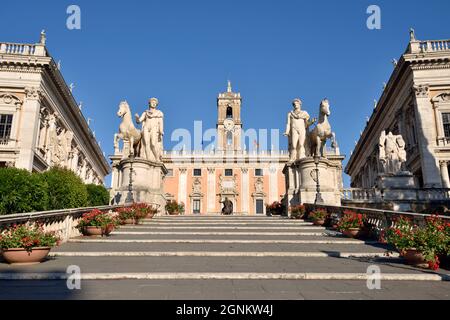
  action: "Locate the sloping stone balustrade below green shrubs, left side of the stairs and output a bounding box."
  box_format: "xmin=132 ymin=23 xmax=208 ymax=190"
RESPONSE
xmin=0 ymin=205 xmax=129 ymax=242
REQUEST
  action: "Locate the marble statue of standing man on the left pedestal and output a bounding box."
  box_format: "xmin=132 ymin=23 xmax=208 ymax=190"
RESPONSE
xmin=135 ymin=98 xmax=164 ymax=162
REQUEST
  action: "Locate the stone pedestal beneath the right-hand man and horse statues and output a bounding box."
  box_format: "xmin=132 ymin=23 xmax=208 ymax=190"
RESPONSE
xmin=283 ymin=156 xmax=344 ymax=215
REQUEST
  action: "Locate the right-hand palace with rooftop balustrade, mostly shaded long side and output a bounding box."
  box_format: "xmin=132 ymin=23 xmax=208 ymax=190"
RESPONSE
xmin=345 ymin=30 xmax=450 ymax=189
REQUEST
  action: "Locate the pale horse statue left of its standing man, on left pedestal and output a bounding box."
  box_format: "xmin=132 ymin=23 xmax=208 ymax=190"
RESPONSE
xmin=114 ymin=101 xmax=142 ymax=157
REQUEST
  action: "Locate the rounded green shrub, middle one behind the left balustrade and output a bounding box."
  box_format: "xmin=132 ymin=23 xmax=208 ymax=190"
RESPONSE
xmin=43 ymin=168 xmax=88 ymax=210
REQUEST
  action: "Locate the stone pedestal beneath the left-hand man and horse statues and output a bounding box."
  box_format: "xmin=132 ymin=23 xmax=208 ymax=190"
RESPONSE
xmin=112 ymin=158 xmax=167 ymax=214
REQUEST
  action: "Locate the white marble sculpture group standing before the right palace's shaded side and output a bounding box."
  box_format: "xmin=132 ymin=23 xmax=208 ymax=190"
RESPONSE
xmin=378 ymin=131 xmax=406 ymax=175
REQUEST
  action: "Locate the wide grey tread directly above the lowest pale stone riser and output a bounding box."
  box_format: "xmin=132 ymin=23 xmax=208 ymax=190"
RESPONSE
xmin=0 ymin=256 xmax=444 ymax=275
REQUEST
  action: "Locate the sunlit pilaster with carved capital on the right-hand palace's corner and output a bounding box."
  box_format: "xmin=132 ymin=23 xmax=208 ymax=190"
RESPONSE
xmin=413 ymin=85 xmax=442 ymax=188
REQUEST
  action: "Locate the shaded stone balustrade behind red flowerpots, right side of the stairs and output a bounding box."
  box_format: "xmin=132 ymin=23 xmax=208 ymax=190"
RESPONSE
xmin=305 ymin=203 xmax=450 ymax=233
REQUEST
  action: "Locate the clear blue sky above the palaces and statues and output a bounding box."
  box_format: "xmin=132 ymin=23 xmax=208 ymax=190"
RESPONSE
xmin=0 ymin=0 xmax=450 ymax=185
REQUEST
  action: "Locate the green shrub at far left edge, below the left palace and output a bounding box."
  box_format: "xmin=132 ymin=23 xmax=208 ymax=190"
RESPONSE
xmin=0 ymin=168 xmax=48 ymax=214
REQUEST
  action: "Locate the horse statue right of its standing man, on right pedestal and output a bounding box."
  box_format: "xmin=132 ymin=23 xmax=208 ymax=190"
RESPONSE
xmin=309 ymin=98 xmax=335 ymax=157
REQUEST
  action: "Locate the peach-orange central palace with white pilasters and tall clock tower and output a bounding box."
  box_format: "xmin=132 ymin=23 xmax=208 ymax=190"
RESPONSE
xmin=163 ymin=82 xmax=289 ymax=215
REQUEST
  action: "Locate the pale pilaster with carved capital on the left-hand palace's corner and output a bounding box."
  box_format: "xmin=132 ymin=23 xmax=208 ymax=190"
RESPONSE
xmin=16 ymin=87 xmax=41 ymax=171
